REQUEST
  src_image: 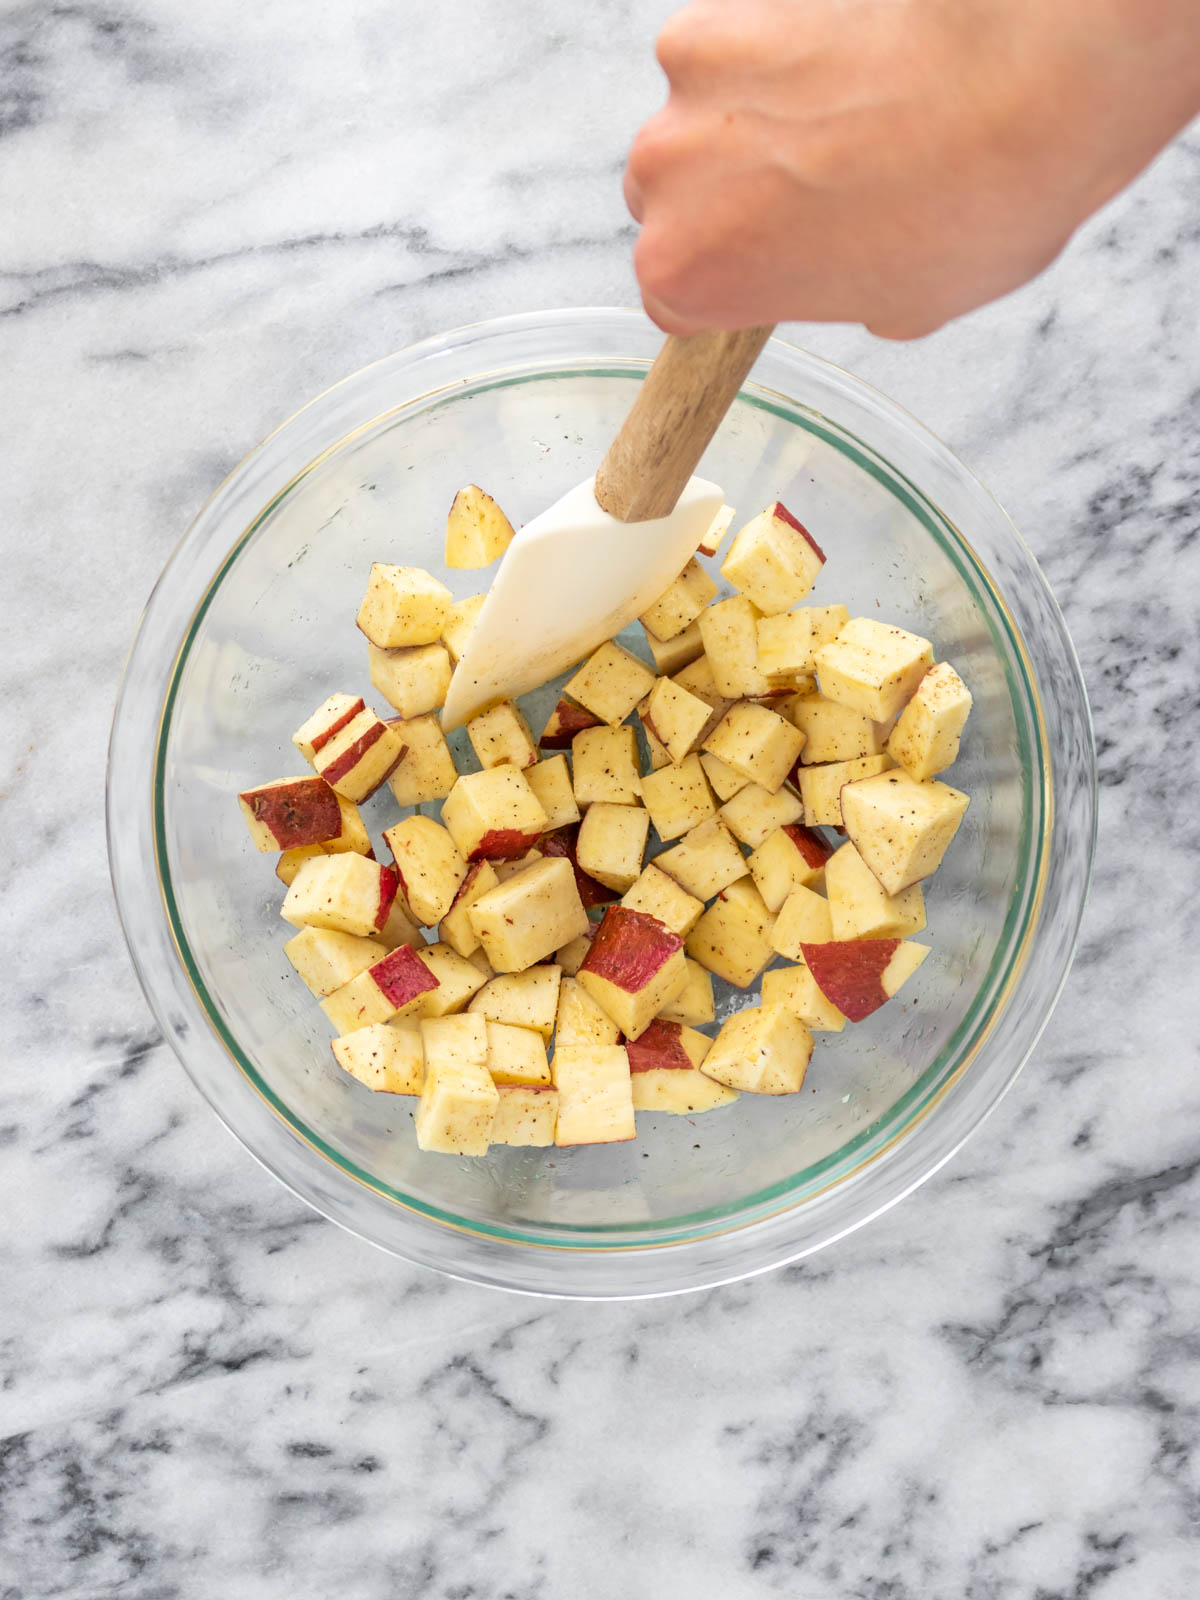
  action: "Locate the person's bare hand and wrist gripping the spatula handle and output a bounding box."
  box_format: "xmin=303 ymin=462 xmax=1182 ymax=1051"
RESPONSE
xmin=626 ymin=0 xmax=1200 ymax=338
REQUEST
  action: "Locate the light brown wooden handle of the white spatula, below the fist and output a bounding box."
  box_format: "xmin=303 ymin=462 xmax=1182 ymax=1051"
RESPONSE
xmin=595 ymin=328 xmax=771 ymax=522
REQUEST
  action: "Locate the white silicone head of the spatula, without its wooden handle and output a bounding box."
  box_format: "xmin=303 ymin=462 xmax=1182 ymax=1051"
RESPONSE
xmin=442 ymin=478 xmax=723 ymax=731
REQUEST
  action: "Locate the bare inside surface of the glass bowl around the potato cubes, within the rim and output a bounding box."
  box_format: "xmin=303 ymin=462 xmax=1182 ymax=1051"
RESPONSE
xmin=155 ymin=360 xmax=1045 ymax=1246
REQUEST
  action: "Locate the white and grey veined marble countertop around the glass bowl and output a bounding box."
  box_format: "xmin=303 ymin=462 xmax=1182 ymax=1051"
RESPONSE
xmin=0 ymin=0 xmax=1200 ymax=1600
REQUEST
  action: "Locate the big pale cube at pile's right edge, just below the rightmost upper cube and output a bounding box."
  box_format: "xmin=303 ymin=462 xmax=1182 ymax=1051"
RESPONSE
xmin=842 ymin=768 xmax=970 ymax=894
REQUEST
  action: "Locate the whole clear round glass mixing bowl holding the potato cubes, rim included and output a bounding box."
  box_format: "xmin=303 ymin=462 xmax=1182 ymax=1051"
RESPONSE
xmin=109 ymin=310 xmax=1094 ymax=1296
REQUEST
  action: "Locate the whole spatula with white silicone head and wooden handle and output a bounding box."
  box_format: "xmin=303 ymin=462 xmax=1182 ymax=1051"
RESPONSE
xmin=442 ymin=328 xmax=771 ymax=731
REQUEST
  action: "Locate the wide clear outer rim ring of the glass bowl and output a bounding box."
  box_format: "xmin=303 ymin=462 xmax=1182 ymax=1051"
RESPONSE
xmin=107 ymin=309 xmax=1096 ymax=1298
